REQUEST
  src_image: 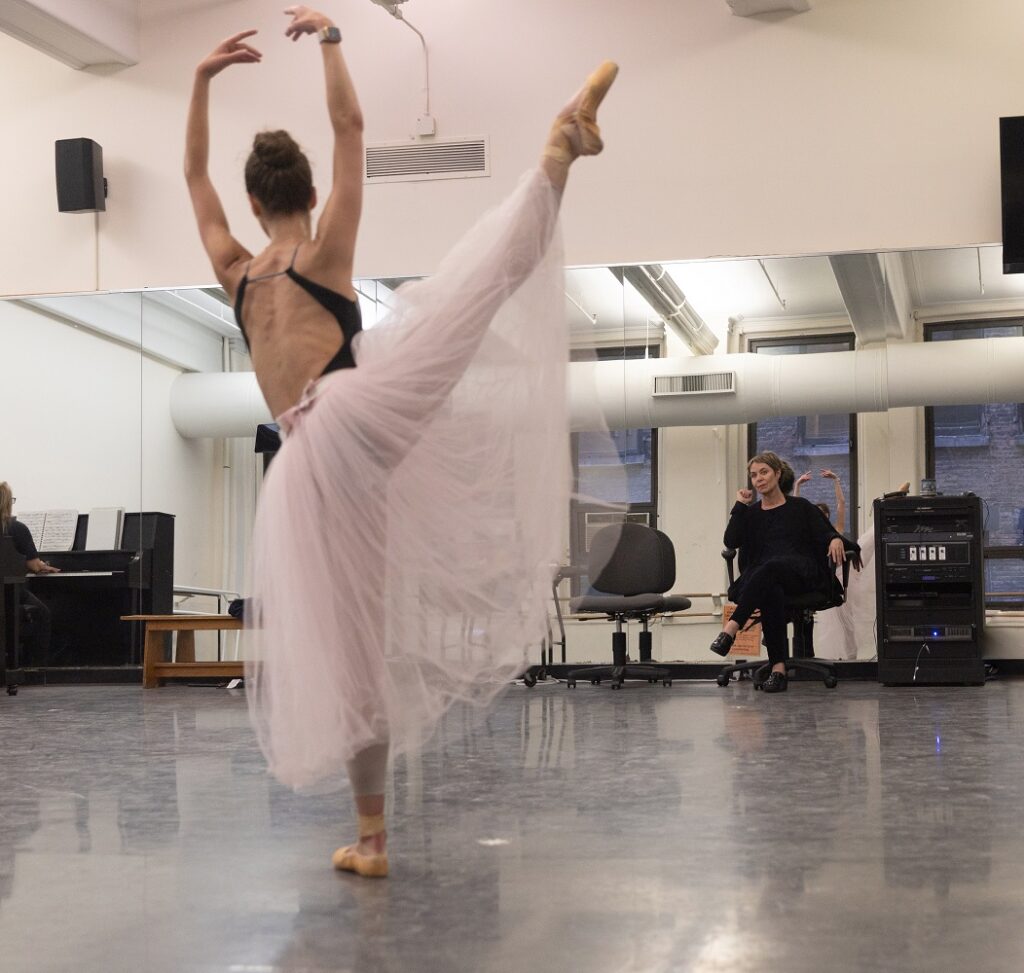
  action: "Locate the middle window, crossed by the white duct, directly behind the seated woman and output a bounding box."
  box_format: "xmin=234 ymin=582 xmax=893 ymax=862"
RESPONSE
xmin=748 ymin=334 xmax=857 ymax=534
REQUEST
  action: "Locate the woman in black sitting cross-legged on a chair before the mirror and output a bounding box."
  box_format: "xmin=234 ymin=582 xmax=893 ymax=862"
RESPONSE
xmin=711 ymin=452 xmax=855 ymax=692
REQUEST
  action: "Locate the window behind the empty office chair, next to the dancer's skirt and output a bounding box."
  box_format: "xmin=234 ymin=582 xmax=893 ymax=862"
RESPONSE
xmin=569 ymin=345 xmax=658 ymax=593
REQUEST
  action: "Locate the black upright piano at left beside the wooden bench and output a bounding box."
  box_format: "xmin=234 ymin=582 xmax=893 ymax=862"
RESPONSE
xmin=28 ymin=513 xmax=174 ymax=668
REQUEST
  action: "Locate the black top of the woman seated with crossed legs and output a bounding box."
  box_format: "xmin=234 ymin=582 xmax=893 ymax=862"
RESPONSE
xmin=725 ymin=497 xmax=839 ymax=588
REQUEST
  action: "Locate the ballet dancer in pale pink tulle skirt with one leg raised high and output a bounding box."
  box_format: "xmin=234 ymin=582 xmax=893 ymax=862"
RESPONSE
xmin=185 ymin=6 xmax=617 ymax=877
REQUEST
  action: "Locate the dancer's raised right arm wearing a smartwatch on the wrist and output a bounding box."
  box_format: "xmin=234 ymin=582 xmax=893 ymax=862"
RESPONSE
xmin=285 ymin=6 xmax=362 ymax=280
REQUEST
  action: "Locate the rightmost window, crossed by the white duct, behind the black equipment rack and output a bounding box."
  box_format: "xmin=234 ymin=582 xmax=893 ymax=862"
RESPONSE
xmin=925 ymin=321 xmax=1024 ymax=608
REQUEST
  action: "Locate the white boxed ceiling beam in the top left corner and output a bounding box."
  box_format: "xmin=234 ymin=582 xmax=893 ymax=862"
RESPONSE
xmin=0 ymin=0 xmax=138 ymax=70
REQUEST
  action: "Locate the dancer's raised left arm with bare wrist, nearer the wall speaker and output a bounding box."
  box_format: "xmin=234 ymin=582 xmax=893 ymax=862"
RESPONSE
xmin=185 ymin=31 xmax=262 ymax=300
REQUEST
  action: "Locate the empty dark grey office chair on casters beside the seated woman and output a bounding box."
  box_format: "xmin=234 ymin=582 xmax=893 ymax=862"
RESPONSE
xmin=566 ymin=523 xmax=690 ymax=689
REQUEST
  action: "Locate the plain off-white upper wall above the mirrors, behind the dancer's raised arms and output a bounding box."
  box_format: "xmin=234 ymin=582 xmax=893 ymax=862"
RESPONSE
xmin=0 ymin=0 xmax=1024 ymax=294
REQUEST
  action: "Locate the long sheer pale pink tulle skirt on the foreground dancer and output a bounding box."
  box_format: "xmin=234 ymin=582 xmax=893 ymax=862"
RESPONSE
xmin=245 ymin=170 xmax=570 ymax=789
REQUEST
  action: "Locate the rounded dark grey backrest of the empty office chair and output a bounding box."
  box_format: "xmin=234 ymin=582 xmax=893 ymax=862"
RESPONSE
xmin=588 ymin=523 xmax=676 ymax=595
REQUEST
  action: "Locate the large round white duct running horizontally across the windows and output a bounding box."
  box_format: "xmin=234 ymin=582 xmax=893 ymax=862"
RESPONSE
xmin=171 ymin=338 xmax=1024 ymax=438
